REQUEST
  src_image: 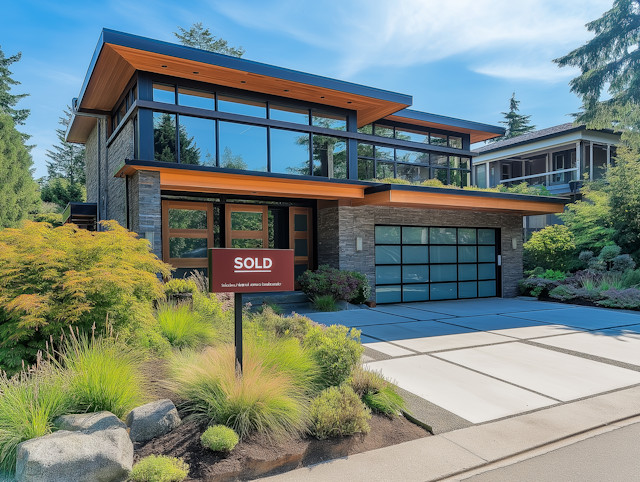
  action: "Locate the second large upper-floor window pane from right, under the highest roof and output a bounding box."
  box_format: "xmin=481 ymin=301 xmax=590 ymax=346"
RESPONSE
xmin=271 ymin=129 xmax=310 ymax=176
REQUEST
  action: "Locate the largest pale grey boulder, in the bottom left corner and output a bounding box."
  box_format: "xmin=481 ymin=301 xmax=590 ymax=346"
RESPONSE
xmin=16 ymin=428 xmax=133 ymax=482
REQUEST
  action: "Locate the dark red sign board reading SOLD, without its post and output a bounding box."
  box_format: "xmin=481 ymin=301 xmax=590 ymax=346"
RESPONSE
xmin=209 ymin=248 xmax=294 ymax=293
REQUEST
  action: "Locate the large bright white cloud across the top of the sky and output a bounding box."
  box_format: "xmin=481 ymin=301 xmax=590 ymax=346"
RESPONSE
xmin=214 ymin=0 xmax=611 ymax=78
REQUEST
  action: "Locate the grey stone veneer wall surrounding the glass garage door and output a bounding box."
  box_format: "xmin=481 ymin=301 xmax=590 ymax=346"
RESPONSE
xmin=318 ymin=206 xmax=523 ymax=297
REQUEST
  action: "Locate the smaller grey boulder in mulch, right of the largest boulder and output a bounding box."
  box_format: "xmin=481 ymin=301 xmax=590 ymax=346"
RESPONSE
xmin=127 ymin=399 xmax=182 ymax=443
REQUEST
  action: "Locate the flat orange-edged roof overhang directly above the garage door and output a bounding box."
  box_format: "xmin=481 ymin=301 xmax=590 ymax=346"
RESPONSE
xmin=351 ymin=184 xmax=568 ymax=216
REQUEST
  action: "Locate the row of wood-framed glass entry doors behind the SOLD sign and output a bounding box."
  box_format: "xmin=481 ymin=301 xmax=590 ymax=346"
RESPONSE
xmin=162 ymin=200 xmax=314 ymax=279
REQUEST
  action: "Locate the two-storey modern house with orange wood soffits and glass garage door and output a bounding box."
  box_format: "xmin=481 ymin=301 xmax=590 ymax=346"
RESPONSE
xmin=67 ymin=30 xmax=565 ymax=303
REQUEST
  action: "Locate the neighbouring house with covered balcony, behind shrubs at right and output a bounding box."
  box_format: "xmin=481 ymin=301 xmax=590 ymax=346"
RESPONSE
xmin=473 ymin=123 xmax=620 ymax=238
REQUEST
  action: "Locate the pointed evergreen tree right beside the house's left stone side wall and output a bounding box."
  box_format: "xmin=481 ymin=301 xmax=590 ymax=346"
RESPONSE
xmin=46 ymin=106 xmax=85 ymax=185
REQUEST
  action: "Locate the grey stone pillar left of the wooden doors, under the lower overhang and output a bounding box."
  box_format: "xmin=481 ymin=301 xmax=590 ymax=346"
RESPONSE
xmin=129 ymin=171 xmax=162 ymax=259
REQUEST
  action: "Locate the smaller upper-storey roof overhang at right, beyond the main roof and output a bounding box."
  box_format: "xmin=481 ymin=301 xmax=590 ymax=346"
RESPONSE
xmin=385 ymin=109 xmax=505 ymax=144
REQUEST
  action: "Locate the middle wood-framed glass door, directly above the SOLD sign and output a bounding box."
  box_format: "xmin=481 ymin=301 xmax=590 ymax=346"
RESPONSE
xmin=225 ymin=204 xmax=269 ymax=249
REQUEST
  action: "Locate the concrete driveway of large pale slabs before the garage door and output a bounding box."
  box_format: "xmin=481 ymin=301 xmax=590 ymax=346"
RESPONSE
xmin=308 ymin=298 xmax=640 ymax=432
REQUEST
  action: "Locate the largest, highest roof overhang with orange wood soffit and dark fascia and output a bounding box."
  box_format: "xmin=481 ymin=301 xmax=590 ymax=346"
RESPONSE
xmin=70 ymin=29 xmax=413 ymax=139
